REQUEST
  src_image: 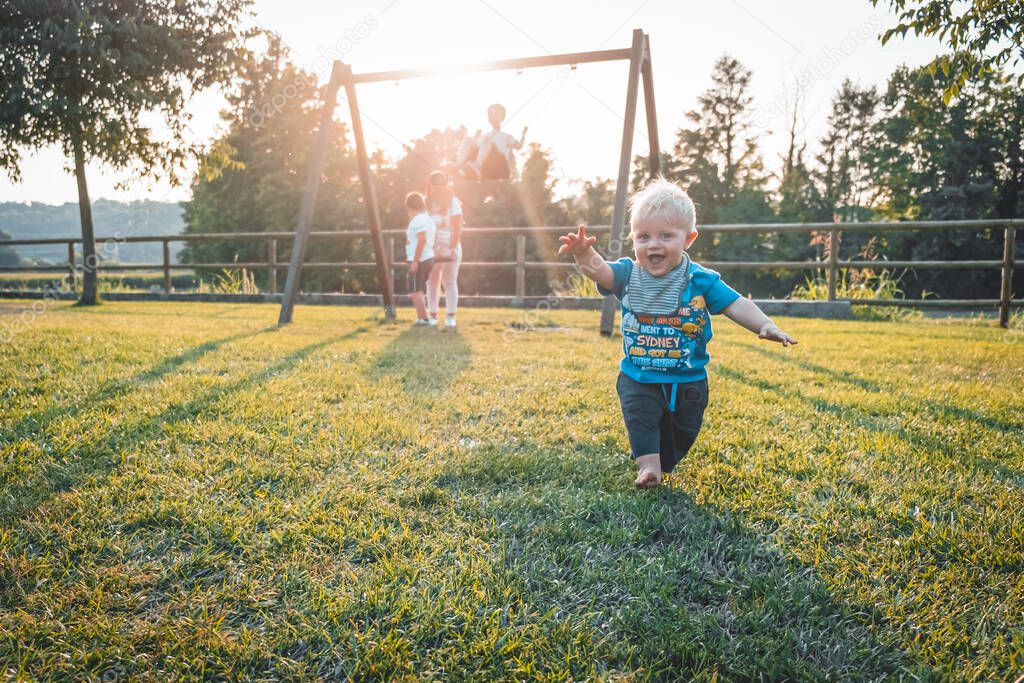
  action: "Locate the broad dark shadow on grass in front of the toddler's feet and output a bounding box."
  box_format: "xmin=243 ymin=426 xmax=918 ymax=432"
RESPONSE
xmin=433 ymin=444 xmax=923 ymax=680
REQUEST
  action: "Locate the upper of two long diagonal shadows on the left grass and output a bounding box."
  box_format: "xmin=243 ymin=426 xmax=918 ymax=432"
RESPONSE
xmin=0 ymin=327 xmax=276 ymax=443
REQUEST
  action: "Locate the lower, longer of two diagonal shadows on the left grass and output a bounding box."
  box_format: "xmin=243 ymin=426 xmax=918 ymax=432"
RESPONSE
xmin=0 ymin=327 xmax=368 ymax=520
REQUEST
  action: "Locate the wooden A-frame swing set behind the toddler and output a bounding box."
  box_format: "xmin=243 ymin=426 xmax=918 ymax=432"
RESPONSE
xmin=278 ymin=29 xmax=660 ymax=335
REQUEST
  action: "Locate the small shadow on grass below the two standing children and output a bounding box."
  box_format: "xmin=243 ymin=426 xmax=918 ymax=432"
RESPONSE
xmin=365 ymin=326 xmax=472 ymax=396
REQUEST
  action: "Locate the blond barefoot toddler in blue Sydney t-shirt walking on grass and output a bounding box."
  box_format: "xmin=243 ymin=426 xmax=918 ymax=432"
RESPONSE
xmin=558 ymin=179 xmax=797 ymax=488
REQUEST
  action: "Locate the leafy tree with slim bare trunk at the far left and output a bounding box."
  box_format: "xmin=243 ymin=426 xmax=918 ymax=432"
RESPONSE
xmin=0 ymin=0 xmax=250 ymax=304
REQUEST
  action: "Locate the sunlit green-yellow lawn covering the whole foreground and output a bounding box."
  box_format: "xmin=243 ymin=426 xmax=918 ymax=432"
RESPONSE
xmin=0 ymin=301 xmax=1024 ymax=681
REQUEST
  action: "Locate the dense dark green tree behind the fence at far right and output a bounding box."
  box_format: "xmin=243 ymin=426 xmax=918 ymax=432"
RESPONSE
xmin=872 ymin=67 xmax=1024 ymax=298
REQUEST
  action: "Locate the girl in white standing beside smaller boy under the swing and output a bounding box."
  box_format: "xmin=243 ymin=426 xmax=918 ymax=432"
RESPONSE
xmin=426 ymin=171 xmax=462 ymax=328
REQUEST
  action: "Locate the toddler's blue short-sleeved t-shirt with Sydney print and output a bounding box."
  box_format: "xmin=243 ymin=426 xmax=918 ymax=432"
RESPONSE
xmin=597 ymin=258 xmax=739 ymax=384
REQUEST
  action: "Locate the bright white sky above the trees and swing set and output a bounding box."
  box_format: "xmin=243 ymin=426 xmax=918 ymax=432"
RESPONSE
xmin=0 ymin=0 xmax=939 ymax=204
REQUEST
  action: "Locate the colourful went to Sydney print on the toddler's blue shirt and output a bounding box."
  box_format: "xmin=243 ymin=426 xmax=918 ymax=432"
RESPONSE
xmin=622 ymin=288 xmax=711 ymax=372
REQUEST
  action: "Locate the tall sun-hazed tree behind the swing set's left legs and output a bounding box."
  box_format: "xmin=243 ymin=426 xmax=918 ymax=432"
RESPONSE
xmin=181 ymin=35 xmax=364 ymax=291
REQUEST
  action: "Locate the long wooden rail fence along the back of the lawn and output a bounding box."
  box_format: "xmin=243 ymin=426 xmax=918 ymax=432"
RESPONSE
xmin=0 ymin=218 xmax=1024 ymax=326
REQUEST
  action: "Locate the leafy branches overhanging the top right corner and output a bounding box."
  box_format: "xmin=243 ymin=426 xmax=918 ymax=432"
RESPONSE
xmin=871 ymin=0 xmax=1024 ymax=104
